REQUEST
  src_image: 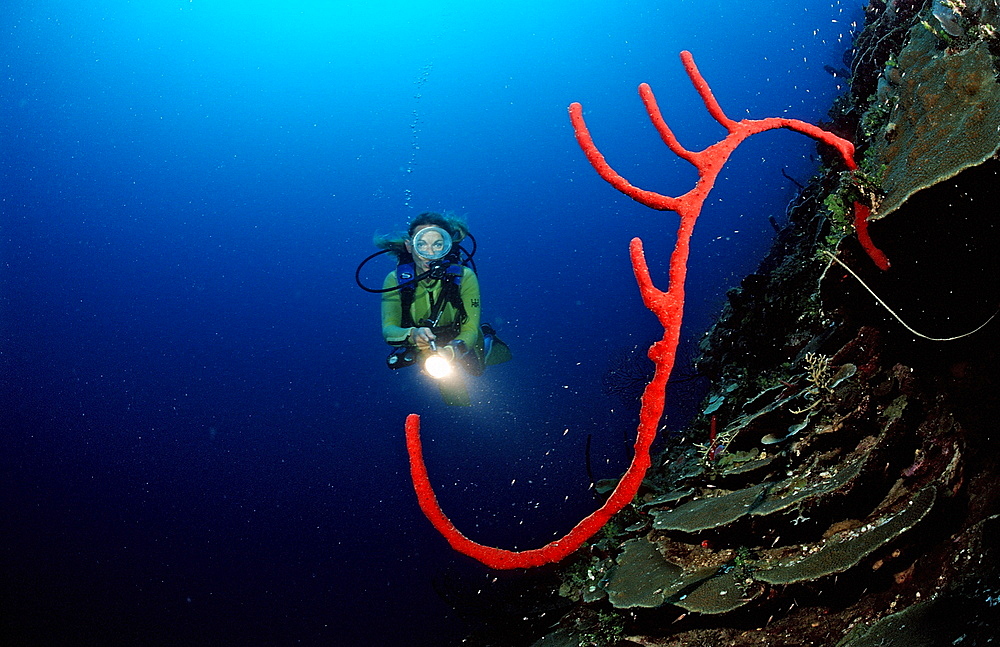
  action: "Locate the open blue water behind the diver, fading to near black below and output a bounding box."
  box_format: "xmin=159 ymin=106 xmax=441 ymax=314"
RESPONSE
xmin=0 ymin=0 xmax=863 ymax=646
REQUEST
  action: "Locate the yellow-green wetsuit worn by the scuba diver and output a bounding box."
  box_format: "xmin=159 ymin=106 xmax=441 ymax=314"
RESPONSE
xmin=382 ymin=267 xmax=483 ymax=361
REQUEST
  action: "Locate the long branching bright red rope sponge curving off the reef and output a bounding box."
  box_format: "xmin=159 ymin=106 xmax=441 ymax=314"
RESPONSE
xmin=406 ymin=52 xmax=889 ymax=569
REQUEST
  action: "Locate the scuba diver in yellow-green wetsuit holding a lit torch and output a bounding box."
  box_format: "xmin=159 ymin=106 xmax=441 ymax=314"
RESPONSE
xmin=355 ymin=212 xmax=511 ymax=406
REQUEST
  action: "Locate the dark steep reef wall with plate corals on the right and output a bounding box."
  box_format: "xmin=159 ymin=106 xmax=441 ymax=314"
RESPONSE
xmin=525 ymin=0 xmax=1000 ymax=647
